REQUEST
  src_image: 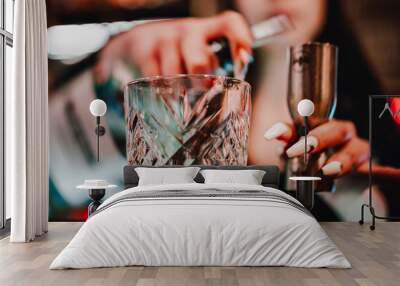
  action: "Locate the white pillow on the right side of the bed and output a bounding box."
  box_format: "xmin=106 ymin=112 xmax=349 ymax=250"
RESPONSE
xmin=200 ymin=169 xmax=265 ymax=185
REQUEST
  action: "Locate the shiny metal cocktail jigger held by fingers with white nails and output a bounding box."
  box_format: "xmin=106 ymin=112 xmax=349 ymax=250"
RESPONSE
xmin=286 ymin=43 xmax=338 ymax=191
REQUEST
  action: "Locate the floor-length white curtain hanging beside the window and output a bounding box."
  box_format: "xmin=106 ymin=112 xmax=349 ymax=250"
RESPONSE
xmin=6 ymin=0 xmax=49 ymax=242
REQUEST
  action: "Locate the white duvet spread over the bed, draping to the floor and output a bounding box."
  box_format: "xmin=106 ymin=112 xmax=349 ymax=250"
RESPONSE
xmin=50 ymin=184 xmax=351 ymax=269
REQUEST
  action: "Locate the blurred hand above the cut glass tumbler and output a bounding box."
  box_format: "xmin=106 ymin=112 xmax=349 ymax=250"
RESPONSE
xmin=94 ymin=11 xmax=252 ymax=82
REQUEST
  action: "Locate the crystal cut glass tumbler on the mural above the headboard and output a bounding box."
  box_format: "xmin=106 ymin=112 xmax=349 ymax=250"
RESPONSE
xmin=125 ymin=75 xmax=251 ymax=166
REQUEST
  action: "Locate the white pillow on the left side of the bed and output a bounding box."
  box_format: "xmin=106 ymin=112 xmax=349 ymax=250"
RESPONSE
xmin=135 ymin=167 xmax=200 ymax=186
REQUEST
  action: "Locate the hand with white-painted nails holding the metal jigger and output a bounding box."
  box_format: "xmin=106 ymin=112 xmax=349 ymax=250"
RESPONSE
xmin=264 ymin=120 xmax=369 ymax=177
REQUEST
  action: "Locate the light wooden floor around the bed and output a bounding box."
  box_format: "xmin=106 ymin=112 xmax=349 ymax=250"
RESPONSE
xmin=0 ymin=222 xmax=400 ymax=286
